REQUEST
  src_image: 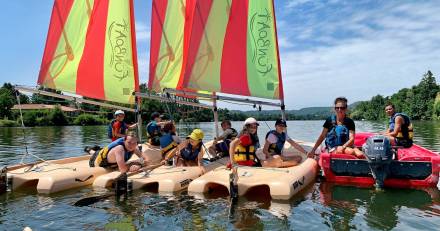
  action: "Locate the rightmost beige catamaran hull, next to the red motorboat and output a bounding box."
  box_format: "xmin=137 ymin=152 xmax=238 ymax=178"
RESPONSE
xmin=188 ymin=143 xmax=318 ymax=200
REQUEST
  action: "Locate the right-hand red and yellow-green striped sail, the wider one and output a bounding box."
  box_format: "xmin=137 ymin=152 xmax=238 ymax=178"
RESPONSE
xmin=149 ymin=0 xmax=283 ymax=99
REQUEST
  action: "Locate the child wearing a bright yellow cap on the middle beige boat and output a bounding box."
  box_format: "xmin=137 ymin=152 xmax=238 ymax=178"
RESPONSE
xmin=168 ymin=129 xmax=206 ymax=172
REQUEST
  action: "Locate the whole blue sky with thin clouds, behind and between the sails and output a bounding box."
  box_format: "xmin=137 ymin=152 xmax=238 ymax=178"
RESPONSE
xmin=0 ymin=0 xmax=440 ymax=110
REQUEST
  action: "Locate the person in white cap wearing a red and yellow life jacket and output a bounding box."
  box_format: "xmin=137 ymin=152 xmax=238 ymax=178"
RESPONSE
xmin=229 ymin=117 xmax=261 ymax=166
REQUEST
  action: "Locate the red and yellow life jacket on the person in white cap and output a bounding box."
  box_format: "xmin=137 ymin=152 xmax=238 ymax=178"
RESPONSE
xmin=233 ymin=135 xmax=257 ymax=166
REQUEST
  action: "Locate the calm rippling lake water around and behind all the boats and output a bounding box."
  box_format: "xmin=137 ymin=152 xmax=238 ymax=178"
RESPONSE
xmin=0 ymin=121 xmax=440 ymax=230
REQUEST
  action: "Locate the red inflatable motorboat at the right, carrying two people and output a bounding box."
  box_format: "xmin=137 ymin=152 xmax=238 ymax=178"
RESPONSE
xmin=319 ymin=133 xmax=440 ymax=188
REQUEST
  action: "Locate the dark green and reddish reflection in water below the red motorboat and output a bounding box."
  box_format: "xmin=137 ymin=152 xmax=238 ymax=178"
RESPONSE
xmin=319 ymin=182 xmax=439 ymax=230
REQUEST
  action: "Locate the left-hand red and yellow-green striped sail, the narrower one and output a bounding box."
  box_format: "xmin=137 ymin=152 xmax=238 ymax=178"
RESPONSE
xmin=38 ymin=0 xmax=139 ymax=104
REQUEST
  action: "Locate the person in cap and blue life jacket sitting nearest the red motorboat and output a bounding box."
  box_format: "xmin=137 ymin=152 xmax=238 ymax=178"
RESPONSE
xmin=262 ymin=119 xmax=307 ymax=168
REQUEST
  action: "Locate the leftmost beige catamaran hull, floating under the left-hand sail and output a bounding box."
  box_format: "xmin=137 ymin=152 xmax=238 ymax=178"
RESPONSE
xmin=8 ymin=155 xmax=110 ymax=194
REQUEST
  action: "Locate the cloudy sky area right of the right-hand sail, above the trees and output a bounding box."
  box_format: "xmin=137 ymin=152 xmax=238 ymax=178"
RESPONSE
xmin=280 ymin=1 xmax=440 ymax=109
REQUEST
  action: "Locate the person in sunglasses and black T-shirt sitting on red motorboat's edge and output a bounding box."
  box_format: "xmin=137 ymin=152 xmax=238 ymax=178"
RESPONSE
xmin=308 ymin=97 xmax=363 ymax=158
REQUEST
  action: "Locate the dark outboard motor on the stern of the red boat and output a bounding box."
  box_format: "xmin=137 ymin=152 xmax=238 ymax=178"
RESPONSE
xmin=362 ymin=135 xmax=393 ymax=188
